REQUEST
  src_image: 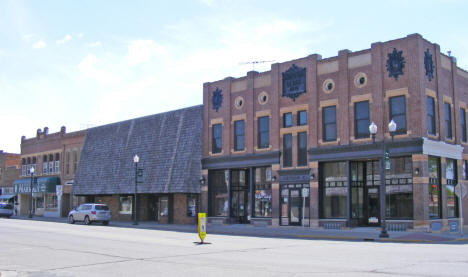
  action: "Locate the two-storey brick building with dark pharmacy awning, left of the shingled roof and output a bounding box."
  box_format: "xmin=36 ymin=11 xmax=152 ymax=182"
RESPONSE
xmin=14 ymin=127 xmax=85 ymax=217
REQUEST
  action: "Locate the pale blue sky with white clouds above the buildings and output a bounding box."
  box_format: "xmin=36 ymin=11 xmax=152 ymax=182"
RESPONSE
xmin=0 ymin=0 xmax=468 ymax=153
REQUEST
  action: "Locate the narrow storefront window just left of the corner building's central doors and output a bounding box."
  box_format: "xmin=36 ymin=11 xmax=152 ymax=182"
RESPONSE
xmin=255 ymin=167 xmax=271 ymax=217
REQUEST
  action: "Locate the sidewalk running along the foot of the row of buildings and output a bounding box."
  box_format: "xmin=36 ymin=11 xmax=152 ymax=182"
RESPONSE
xmin=12 ymin=216 xmax=468 ymax=244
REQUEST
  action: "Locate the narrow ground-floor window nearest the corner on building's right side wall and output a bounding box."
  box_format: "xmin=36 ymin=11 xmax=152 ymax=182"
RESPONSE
xmin=428 ymin=157 xmax=441 ymax=218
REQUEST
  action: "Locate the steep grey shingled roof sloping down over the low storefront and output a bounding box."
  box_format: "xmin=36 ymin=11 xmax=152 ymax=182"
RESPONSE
xmin=73 ymin=105 xmax=202 ymax=195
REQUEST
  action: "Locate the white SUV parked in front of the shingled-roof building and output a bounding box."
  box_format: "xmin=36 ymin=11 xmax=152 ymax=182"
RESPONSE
xmin=68 ymin=203 xmax=111 ymax=225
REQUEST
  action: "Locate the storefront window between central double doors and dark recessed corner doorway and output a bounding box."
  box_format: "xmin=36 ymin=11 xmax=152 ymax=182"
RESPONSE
xmin=320 ymin=162 xmax=348 ymax=218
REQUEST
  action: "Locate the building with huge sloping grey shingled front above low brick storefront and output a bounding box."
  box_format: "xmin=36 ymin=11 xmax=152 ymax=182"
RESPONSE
xmin=73 ymin=106 xmax=202 ymax=224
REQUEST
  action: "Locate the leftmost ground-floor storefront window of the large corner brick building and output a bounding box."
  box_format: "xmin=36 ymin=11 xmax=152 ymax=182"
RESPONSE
xmin=208 ymin=170 xmax=229 ymax=216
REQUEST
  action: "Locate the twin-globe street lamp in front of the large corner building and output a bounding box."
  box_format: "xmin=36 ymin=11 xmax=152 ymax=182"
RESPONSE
xmin=369 ymin=119 xmax=397 ymax=238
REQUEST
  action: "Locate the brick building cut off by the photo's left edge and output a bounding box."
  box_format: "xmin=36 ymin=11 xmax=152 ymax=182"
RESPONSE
xmin=0 ymin=150 xmax=21 ymax=203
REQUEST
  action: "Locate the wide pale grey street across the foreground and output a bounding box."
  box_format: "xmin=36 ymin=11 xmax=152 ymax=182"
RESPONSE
xmin=0 ymin=218 xmax=468 ymax=277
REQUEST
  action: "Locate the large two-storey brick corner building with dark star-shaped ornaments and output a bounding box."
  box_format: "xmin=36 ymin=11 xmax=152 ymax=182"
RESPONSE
xmin=201 ymin=34 xmax=468 ymax=230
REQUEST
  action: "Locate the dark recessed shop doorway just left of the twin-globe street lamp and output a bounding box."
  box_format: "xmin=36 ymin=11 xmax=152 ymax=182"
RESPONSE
xmin=350 ymin=161 xmax=380 ymax=226
